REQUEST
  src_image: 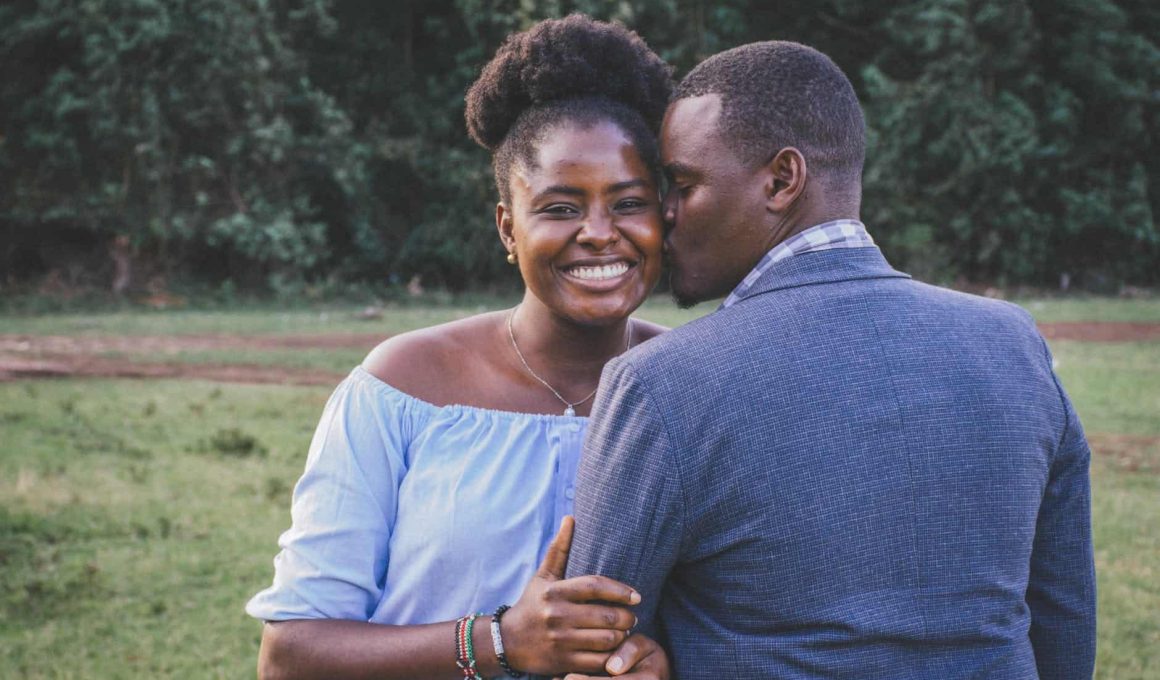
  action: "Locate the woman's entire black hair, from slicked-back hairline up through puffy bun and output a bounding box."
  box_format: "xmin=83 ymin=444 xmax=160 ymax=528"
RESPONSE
xmin=466 ymin=14 xmax=673 ymax=204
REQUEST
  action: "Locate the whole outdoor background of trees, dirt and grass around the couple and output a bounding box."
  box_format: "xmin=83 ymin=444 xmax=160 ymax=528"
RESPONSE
xmin=0 ymin=0 xmax=1160 ymax=680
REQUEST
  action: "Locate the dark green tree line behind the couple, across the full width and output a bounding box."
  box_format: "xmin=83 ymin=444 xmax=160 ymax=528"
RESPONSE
xmin=0 ymin=0 xmax=1160 ymax=289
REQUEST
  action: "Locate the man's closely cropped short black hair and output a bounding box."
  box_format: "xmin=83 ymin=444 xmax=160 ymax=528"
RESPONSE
xmin=676 ymin=41 xmax=865 ymax=188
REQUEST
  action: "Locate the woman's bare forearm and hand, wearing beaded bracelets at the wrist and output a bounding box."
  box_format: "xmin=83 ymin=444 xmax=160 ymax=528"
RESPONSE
xmin=258 ymin=518 xmax=640 ymax=680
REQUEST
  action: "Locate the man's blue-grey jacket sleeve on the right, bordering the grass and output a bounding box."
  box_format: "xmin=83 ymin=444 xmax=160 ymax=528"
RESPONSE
xmin=1027 ymin=369 xmax=1095 ymax=680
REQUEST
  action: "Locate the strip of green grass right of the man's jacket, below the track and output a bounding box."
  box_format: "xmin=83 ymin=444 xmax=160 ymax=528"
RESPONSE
xmin=1051 ymin=341 xmax=1160 ymax=680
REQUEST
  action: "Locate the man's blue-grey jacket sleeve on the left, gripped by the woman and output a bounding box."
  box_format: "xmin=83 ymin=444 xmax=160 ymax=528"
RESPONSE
xmin=567 ymin=361 xmax=684 ymax=635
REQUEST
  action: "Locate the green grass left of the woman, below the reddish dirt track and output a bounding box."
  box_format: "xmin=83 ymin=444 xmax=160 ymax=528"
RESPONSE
xmin=0 ymin=381 xmax=328 ymax=678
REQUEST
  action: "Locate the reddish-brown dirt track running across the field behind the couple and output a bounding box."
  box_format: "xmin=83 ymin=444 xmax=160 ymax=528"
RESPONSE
xmin=0 ymin=323 xmax=1160 ymax=385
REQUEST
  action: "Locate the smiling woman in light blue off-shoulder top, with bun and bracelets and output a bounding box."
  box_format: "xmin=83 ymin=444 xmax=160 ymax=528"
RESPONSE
xmin=247 ymin=15 xmax=672 ymax=678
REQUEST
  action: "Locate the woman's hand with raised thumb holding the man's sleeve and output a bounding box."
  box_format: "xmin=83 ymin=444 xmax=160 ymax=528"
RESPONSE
xmin=500 ymin=516 xmax=640 ymax=675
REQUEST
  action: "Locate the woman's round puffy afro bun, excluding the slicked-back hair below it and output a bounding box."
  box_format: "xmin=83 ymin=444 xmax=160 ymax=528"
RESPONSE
xmin=466 ymin=14 xmax=673 ymax=152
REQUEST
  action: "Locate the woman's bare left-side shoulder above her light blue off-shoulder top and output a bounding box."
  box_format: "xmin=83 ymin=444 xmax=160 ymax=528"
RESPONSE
xmin=362 ymin=312 xmax=502 ymax=404
